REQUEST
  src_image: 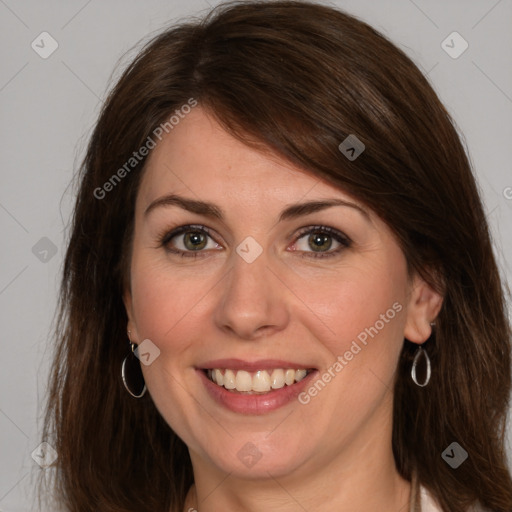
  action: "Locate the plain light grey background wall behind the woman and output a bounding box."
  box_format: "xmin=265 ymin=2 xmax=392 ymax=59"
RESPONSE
xmin=0 ymin=0 xmax=512 ymax=512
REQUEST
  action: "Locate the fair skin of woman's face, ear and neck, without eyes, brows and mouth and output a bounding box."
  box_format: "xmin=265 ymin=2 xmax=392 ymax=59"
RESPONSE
xmin=124 ymin=106 xmax=442 ymax=512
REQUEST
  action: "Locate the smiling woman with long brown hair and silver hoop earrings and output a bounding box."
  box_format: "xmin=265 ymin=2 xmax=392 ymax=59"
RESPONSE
xmin=44 ymin=1 xmax=512 ymax=512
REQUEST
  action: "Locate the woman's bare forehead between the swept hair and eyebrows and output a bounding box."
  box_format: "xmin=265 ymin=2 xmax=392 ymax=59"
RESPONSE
xmin=139 ymin=106 xmax=366 ymax=214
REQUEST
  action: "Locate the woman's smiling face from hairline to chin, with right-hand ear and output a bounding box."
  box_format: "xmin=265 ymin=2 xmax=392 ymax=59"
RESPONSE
xmin=125 ymin=106 xmax=439 ymax=478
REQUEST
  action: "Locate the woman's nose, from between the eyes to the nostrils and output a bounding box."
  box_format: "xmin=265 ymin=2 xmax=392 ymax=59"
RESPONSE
xmin=214 ymin=246 xmax=290 ymax=341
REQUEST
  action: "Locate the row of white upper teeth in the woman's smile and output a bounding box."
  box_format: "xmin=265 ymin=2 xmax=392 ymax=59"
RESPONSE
xmin=208 ymin=368 xmax=308 ymax=393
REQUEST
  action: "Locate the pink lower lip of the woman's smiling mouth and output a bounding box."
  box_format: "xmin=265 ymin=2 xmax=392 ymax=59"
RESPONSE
xmin=196 ymin=369 xmax=318 ymax=414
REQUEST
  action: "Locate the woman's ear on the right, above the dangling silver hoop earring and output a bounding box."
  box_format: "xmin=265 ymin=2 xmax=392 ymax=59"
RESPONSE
xmin=404 ymin=274 xmax=443 ymax=345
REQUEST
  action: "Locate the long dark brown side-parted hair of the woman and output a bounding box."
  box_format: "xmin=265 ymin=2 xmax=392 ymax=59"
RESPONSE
xmin=44 ymin=1 xmax=512 ymax=512
